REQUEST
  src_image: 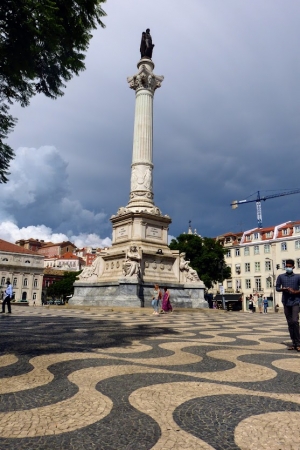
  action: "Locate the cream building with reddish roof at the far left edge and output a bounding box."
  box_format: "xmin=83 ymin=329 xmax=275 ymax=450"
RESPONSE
xmin=0 ymin=239 xmax=44 ymax=304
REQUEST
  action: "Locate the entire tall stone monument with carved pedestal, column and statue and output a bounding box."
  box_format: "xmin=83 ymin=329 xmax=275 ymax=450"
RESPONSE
xmin=69 ymin=36 xmax=207 ymax=308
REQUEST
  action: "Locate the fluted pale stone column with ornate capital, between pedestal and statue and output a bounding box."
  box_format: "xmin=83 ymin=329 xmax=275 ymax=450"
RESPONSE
xmin=126 ymin=57 xmax=164 ymax=211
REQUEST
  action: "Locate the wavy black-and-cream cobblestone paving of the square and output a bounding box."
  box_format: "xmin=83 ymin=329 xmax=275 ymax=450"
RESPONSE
xmin=0 ymin=306 xmax=300 ymax=450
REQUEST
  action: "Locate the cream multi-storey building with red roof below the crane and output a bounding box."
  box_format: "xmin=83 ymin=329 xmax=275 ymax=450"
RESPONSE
xmin=214 ymin=221 xmax=300 ymax=309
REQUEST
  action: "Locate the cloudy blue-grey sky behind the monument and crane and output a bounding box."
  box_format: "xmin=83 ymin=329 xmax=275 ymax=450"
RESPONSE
xmin=0 ymin=0 xmax=300 ymax=245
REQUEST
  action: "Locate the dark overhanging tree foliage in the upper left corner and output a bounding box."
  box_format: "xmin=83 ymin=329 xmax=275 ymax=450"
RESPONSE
xmin=0 ymin=0 xmax=106 ymax=183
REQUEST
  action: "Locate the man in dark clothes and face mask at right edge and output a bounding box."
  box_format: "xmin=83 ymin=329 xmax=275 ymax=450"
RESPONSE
xmin=276 ymin=259 xmax=300 ymax=352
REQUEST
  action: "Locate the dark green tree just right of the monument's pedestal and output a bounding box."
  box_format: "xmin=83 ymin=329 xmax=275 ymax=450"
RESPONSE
xmin=169 ymin=234 xmax=231 ymax=289
